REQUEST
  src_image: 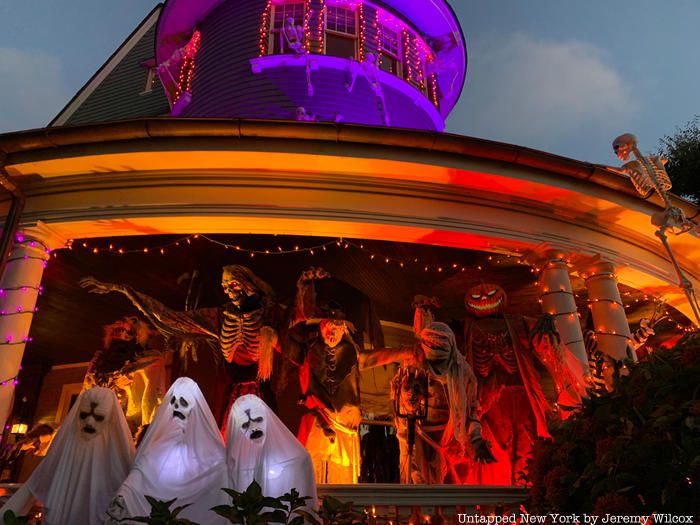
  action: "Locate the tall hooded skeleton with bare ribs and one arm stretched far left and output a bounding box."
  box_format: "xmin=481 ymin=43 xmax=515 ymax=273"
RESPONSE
xmin=81 ymin=265 xmax=279 ymax=420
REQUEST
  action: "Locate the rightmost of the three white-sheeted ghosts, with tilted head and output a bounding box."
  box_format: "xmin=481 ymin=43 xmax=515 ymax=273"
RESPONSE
xmin=226 ymin=394 xmax=317 ymax=510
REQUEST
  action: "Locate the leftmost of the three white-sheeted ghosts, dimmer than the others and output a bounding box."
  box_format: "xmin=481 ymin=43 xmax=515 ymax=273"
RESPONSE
xmin=0 ymin=387 xmax=134 ymax=525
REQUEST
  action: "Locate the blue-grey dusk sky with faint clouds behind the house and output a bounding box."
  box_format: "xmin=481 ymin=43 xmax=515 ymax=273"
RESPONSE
xmin=0 ymin=0 xmax=700 ymax=164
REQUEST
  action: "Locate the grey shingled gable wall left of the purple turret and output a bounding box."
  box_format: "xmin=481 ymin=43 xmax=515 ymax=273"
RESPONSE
xmin=66 ymin=24 xmax=170 ymax=124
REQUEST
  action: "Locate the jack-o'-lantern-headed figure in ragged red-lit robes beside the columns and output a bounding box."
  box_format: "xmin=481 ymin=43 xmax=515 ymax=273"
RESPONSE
xmin=464 ymin=283 xmax=561 ymax=485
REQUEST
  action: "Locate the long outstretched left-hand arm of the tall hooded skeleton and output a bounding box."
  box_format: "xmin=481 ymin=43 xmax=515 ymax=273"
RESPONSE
xmin=80 ymin=277 xmax=218 ymax=340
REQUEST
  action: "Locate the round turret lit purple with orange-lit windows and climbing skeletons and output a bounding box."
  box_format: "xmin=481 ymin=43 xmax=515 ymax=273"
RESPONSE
xmin=156 ymin=0 xmax=466 ymax=131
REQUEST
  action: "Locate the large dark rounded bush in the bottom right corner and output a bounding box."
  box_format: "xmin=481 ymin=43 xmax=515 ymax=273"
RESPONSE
xmin=527 ymin=333 xmax=700 ymax=514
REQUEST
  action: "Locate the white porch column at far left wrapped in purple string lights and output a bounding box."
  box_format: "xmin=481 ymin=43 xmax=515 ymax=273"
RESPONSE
xmin=0 ymin=224 xmax=63 ymax=429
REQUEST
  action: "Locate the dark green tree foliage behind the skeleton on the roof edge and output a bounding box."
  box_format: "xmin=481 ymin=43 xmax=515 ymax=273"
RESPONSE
xmin=659 ymin=116 xmax=700 ymax=203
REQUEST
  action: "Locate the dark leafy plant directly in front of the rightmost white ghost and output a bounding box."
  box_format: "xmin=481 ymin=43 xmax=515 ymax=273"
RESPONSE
xmin=212 ymin=480 xmax=318 ymax=525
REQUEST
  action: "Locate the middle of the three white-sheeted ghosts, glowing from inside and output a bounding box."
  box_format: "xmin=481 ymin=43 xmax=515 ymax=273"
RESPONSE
xmin=109 ymin=377 xmax=227 ymax=524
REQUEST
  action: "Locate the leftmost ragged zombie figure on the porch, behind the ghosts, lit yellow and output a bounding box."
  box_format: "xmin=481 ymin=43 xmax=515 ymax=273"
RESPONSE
xmin=83 ymin=317 xmax=165 ymax=433
